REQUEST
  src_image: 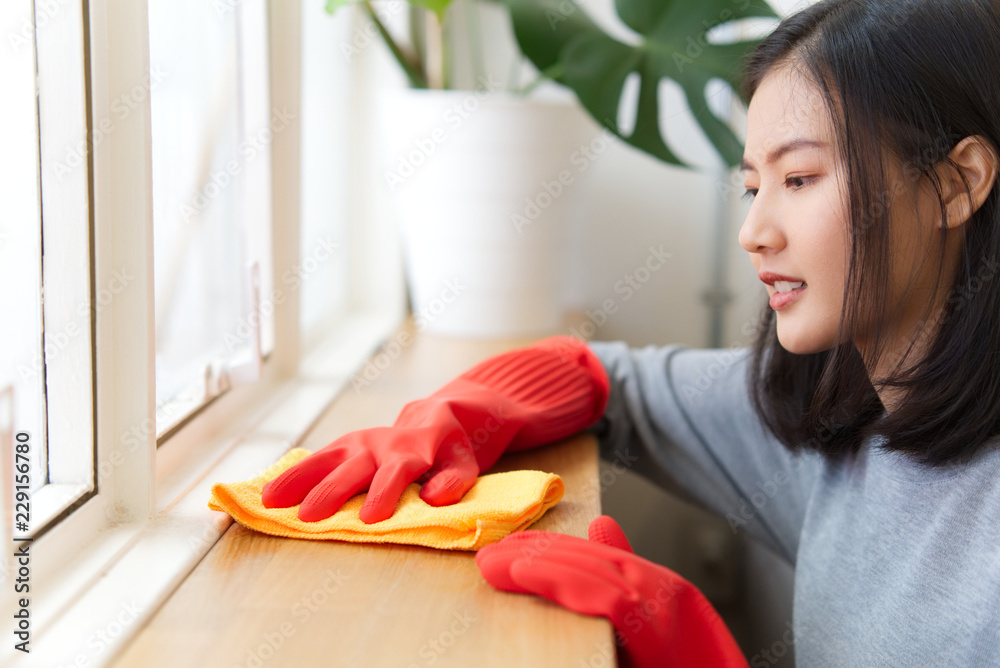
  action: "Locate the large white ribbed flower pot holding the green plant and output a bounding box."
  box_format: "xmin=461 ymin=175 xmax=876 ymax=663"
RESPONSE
xmin=378 ymin=89 xmax=588 ymax=338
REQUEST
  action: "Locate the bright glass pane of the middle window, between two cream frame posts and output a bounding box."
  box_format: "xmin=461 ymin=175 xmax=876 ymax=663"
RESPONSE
xmin=149 ymin=0 xmax=274 ymax=435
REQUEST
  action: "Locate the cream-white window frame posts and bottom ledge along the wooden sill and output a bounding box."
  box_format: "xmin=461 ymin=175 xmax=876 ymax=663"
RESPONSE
xmin=0 ymin=0 xmax=406 ymax=667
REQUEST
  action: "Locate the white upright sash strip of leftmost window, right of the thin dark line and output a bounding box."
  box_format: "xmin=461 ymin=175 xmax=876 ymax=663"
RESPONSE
xmin=28 ymin=0 xmax=96 ymax=536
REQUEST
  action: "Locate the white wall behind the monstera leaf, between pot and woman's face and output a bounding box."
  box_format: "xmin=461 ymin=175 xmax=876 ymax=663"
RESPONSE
xmin=454 ymin=0 xmax=784 ymax=346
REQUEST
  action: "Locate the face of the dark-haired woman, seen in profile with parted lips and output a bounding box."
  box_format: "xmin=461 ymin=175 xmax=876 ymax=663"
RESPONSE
xmin=740 ymin=67 xmax=850 ymax=354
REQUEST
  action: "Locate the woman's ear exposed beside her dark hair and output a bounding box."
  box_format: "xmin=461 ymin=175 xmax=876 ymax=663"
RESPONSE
xmin=938 ymin=135 xmax=998 ymax=228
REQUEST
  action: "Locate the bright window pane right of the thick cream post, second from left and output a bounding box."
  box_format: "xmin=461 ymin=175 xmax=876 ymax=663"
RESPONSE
xmin=149 ymin=0 xmax=270 ymax=422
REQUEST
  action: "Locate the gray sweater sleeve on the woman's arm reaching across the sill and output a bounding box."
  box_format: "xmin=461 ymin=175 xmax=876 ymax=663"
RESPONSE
xmin=590 ymin=342 xmax=822 ymax=564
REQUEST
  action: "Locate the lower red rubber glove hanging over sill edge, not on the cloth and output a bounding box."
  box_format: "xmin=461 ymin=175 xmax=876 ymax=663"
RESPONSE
xmin=476 ymin=515 xmax=747 ymax=668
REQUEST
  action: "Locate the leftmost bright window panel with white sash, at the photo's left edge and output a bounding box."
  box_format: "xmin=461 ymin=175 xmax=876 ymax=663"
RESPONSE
xmin=0 ymin=0 xmax=95 ymax=535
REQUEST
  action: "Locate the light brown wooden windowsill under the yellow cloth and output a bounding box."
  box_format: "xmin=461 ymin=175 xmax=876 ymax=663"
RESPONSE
xmin=107 ymin=324 xmax=614 ymax=668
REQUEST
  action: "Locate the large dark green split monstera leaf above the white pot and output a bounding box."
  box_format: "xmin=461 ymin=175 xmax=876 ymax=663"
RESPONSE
xmin=500 ymin=0 xmax=778 ymax=166
